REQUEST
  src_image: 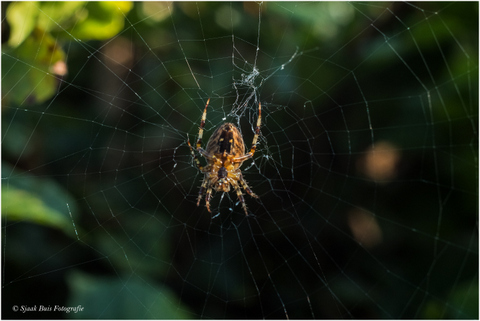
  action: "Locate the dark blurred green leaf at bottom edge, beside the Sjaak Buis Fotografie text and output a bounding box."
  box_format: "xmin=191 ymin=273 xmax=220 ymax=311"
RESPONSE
xmin=67 ymin=271 xmax=193 ymax=320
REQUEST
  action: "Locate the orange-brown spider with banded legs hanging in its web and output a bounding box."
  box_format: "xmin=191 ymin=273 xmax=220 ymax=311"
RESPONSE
xmin=187 ymin=99 xmax=262 ymax=216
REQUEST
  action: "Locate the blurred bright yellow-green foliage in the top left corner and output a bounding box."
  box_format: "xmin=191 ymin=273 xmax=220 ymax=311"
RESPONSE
xmin=2 ymin=1 xmax=132 ymax=104
